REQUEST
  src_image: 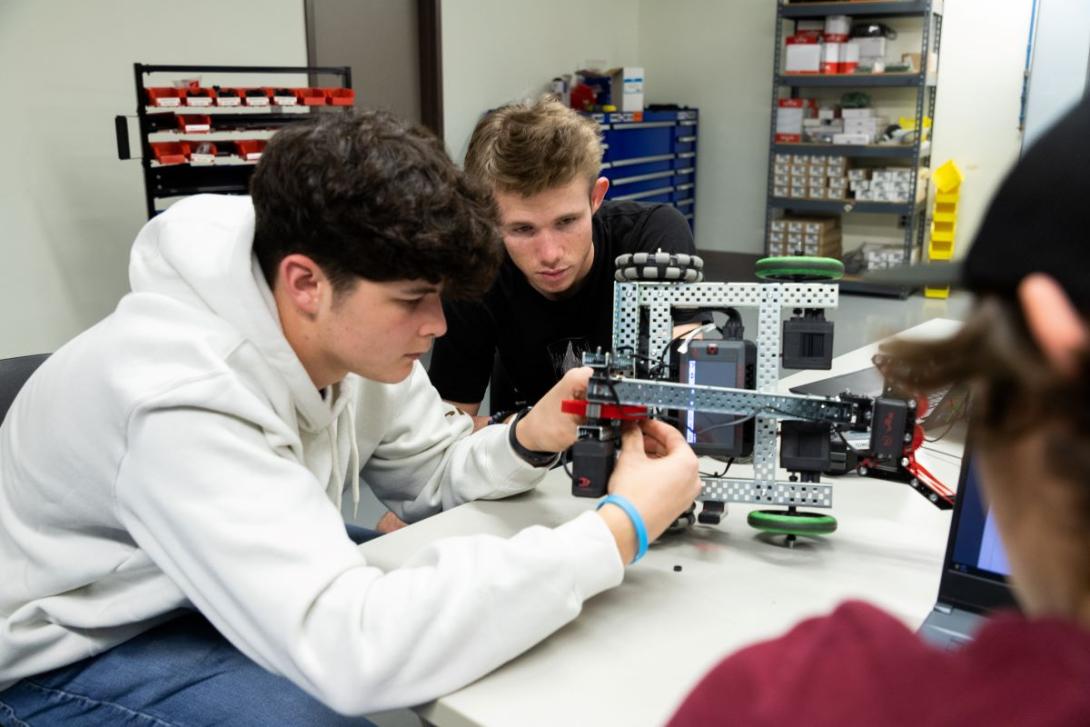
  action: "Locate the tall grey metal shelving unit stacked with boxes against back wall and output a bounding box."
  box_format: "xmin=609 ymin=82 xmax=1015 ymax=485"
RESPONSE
xmin=765 ymin=0 xmax=943 ymax=298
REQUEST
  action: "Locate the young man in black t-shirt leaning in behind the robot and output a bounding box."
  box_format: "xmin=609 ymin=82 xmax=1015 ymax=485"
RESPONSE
xmin=428 ymin=98 xmax=695 ymax=425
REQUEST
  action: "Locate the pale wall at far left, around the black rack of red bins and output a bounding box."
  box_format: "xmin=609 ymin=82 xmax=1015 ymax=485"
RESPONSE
xmin=0 ymin=0 xmax=306 ymax=356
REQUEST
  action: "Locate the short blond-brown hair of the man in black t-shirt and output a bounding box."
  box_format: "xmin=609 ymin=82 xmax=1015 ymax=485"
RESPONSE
xmin=465 ymin=96 xmax=602 ymax=197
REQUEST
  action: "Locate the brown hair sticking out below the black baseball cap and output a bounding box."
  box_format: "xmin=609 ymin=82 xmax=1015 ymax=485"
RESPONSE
xmin=875 ymin=294 xmax=1090 ymax=488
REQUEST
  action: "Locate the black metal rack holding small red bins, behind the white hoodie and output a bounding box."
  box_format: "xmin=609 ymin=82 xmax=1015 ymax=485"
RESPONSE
xmin=114 ymin=63 xmax=352 ymax=219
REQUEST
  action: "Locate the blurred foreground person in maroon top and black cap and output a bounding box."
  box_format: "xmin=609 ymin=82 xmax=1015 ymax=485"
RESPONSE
xmin=669 ymin=99 xmax=1090 ymax=727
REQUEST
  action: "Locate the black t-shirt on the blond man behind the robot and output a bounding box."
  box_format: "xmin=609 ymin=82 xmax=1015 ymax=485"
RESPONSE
xmin=428 ymin=201 xmax=695 ymax=410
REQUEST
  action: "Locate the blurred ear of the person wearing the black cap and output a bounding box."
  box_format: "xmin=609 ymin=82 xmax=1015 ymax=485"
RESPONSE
xmin=1018 ymin=272 xmax=1090 ymax=376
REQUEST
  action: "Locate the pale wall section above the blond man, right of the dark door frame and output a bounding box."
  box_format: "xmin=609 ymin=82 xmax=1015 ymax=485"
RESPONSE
xmin=443 ymin=0 xmax=642 ymax=162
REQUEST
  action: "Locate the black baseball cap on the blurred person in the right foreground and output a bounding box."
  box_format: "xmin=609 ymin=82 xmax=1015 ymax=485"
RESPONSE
xmin=863 ymin=91 xmax=1090 ymax=314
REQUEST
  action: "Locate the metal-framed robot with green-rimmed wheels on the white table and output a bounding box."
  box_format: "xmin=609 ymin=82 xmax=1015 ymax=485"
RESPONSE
xmin=562 ymin=252 xmax=954 ymax=546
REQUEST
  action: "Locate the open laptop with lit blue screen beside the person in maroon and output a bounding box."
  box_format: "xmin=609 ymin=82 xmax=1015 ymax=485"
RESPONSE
xmin=919 ymin=449 xmax=1017 ymax=650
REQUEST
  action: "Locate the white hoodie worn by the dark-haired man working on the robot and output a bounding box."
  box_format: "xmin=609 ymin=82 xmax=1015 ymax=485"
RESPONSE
xmin=0 ymin=195 xmax=623 ymax=714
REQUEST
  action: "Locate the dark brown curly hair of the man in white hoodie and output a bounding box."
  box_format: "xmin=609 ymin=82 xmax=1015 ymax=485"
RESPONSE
xmin=250 ymin=111 xmax=502 ymax=299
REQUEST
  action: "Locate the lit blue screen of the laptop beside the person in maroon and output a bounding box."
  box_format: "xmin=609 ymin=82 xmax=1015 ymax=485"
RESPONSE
xmin=949 ymin=455 xmax=1010 ymax=579
